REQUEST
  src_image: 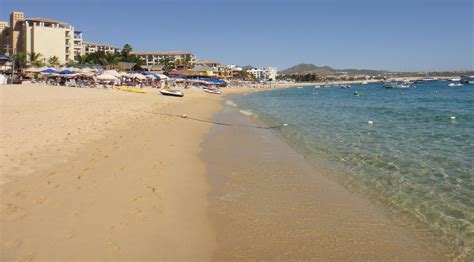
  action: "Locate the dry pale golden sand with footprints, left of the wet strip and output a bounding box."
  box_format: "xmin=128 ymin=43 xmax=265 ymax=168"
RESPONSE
xmin=0 ymin=85 xmax=221 ymax=260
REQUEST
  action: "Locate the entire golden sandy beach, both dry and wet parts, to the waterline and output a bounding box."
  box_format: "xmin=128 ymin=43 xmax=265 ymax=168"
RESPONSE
xmin=0 ymin=82 xmax=448 ymax=261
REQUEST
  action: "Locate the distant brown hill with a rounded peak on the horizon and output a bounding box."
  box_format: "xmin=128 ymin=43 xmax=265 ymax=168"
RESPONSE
xmin=280 ymin=64 xmax=388 ymax=75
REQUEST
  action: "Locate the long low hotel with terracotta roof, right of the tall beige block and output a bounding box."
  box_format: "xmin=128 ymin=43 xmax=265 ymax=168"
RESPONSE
xmin=130 ymin=51 xmax=196 ymax=66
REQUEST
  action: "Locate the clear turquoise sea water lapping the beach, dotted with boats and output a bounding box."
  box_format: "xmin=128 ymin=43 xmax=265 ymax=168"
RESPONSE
xmin=232 ymin=81 xmax=474 ymax=260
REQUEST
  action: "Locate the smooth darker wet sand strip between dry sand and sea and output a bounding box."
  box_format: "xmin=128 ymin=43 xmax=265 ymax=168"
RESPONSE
xmin=201 ymin=100 xmax=446 ymax=261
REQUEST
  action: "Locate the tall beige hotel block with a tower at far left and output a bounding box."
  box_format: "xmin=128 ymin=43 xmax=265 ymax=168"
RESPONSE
xmin=0 ymin=12 xmax=84 ymax=64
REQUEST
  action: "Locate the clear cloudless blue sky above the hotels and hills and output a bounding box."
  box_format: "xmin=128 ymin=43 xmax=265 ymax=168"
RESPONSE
xmin=0 ymin=0 xmax=474 ymax=71
